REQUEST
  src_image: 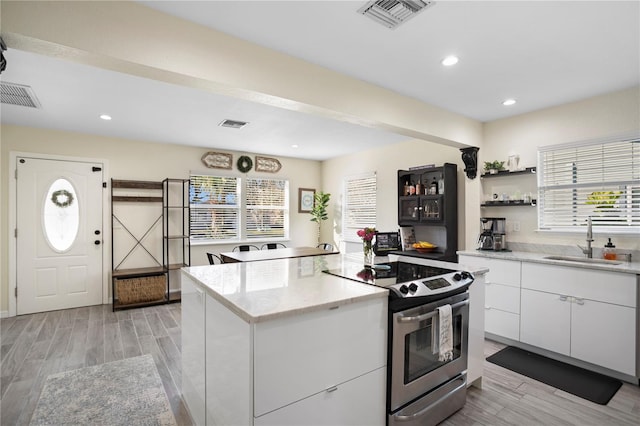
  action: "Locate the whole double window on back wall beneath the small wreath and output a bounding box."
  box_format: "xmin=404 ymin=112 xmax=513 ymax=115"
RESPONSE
xmin=189 ymin=175 xmax=289 ymax=242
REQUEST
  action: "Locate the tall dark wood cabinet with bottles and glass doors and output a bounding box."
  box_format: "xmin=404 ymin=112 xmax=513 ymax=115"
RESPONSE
xmin=398 ymin=163 xmax=458 ymax=261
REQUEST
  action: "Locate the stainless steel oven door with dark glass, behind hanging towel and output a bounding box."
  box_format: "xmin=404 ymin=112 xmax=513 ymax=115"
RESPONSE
xmin=390 ymin=293 xmax=469 ymax=412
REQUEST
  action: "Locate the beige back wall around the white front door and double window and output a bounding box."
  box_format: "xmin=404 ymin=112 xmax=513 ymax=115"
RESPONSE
xmin=0 ymin=125 xmax=321 ymax=311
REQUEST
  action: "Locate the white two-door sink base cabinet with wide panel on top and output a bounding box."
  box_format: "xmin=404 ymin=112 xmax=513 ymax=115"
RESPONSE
xmin=520 ymin=263 xmax=637 ymax=376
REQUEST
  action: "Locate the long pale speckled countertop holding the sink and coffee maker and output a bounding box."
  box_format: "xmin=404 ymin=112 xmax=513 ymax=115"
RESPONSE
xmin=458 ymin=250 xmax=640 ymax=275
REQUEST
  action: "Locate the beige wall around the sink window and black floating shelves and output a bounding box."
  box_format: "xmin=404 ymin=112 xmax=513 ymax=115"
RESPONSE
xmin=479 ymin=87 xmax=640 ymax=250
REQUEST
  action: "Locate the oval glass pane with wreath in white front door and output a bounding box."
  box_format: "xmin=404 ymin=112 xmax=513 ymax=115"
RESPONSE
xmin=42 ymin=179 xmax=80 ymax=252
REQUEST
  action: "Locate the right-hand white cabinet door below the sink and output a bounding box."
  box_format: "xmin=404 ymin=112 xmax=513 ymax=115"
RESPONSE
xmin=571 ymin=299 xmax=636 ymax=376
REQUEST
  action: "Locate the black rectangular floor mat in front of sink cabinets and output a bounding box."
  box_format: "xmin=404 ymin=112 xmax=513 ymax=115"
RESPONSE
xmin=487 ymin=346 xmax=622 ymax=405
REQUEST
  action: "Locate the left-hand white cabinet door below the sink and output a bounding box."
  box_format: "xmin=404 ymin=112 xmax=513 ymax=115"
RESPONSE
xmin=520 ymin=289 xmax=571 ymax=356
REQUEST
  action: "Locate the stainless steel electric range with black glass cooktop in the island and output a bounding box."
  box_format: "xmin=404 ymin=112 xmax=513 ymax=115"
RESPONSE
xmin=324 ymin=261 xmax=474 ymax=426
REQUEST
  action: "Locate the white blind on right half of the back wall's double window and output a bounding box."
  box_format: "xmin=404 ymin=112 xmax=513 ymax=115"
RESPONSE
xmin=246 ymin=179 xmax=289 ymax=239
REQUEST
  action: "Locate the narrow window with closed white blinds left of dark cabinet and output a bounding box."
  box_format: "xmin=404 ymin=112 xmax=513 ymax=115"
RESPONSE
xmin=342 ymin=173 xmax=377 ymax=242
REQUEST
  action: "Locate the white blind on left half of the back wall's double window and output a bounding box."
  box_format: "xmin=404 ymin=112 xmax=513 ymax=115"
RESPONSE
xmin=189 ymin=175 xmax=240 ymax=241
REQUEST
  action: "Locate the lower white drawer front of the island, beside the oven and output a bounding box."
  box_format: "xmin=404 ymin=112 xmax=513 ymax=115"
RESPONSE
xmin=254 ymin=367 xmax=386 ymax=426
